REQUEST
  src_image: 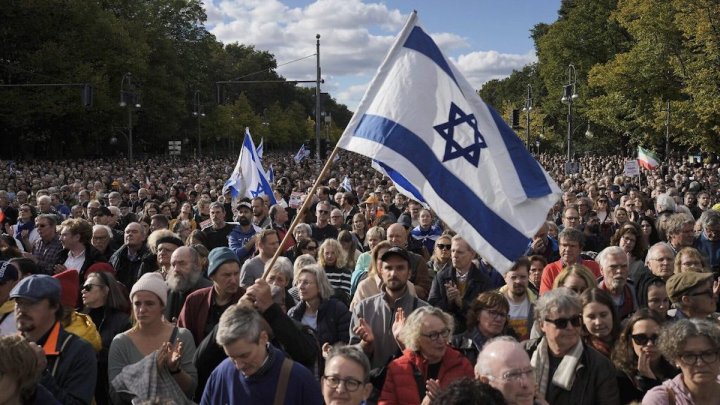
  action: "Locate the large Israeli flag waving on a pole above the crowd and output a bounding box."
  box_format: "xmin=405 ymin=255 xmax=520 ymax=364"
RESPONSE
xmin=338 ymin=12 xmax=560 ymax=272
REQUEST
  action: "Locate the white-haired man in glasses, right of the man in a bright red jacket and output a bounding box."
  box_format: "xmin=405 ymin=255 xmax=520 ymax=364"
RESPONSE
xmin=595 ymin=246 xmax=637 ymax=320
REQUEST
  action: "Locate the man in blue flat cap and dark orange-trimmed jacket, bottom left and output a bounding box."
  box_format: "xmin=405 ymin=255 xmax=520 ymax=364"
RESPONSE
xmin=10 ymin=274 xmax=97 ymax=405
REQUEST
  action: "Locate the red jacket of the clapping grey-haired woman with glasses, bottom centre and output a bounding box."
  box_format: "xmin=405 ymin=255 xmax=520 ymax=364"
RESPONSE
xmin=378 ymin=346 xmax=474 ymax=405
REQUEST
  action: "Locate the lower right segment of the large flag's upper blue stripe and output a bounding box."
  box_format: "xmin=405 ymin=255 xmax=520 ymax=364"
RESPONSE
xmin=487 ymin=106 xmax=552 ymax=198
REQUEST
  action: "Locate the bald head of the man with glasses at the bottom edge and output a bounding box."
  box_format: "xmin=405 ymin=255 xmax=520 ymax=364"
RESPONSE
xmin=475 ymin=337 xmax=535 ymax=405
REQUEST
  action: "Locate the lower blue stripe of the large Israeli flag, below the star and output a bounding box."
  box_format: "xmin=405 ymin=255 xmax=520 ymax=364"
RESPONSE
xmin=354 ymin=114 xmax=530 ymax=260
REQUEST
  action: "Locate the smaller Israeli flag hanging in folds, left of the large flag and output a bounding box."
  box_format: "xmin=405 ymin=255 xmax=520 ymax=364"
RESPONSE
xmin=223 ymin=128 xmax=275 ymax=204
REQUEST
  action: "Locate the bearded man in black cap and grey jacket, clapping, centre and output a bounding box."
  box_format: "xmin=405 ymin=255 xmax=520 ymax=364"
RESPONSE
xmin=350 ymin=247 xmax=428 ymax=368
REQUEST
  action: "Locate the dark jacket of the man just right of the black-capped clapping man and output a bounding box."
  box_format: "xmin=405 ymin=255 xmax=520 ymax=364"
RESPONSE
xmin=428 ymin=263 xmax=492 ymax=333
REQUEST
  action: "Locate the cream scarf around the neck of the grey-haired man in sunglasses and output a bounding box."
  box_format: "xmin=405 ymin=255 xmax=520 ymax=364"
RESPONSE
xmin=530 ymin=337 xmax=583 ymax=399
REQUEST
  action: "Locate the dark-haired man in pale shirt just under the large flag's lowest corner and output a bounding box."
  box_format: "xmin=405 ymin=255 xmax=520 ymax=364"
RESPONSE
xmin=500 ymin=257 xmax=537 ymax=341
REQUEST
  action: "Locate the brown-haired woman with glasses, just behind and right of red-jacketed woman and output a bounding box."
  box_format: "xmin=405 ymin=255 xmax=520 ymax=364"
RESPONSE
xmin=450 ymin=291 xmax=516 ymax=364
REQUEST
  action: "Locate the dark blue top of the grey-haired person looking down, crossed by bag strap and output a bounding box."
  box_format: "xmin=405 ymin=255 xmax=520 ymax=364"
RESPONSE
xmin=200 ymin=345 xmax=323 ymax=405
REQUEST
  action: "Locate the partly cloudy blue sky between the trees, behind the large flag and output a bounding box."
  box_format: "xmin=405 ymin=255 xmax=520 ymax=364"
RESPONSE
xmin=205 ymin=0 xmax=560 ymax=110
